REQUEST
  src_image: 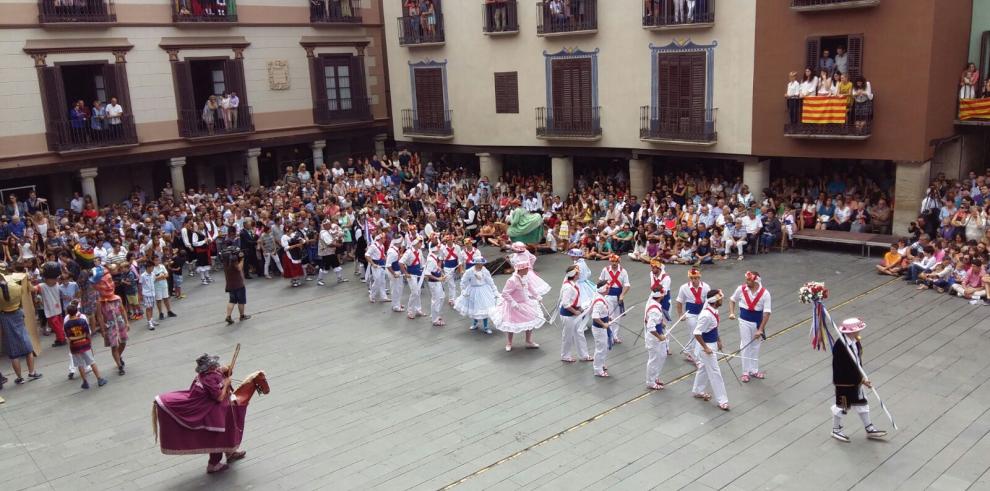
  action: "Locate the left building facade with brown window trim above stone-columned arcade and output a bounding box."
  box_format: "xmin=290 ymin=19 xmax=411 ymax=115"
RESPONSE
xmin=0 ymin=0 xmax=391 ymax=208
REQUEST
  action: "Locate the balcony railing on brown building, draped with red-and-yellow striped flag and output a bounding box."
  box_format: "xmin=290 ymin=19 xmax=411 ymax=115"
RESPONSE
xmin=784 ymin=93 xmax=875 ymax=140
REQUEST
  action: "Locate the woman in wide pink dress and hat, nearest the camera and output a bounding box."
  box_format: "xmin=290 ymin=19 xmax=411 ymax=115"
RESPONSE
xmin=488 ymin=256 xmax=546 ymax=351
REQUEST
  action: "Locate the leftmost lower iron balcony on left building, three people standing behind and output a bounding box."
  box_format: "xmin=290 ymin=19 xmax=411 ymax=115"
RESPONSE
xmin=47 ymin=114 xmax=138 ymax=152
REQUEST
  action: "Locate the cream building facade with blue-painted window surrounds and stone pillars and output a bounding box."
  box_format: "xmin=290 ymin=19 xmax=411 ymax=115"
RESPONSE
xmin=383 ymin=0 xmax=756 ymax=197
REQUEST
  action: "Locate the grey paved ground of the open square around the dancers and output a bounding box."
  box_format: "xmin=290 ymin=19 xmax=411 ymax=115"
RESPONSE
xmin=0 ymin=251 xmax=990 ymax=490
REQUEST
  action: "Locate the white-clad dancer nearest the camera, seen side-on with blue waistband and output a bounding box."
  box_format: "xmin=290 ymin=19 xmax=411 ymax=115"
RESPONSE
xmin=691 ymin=290 xmax=729 ymax=411
